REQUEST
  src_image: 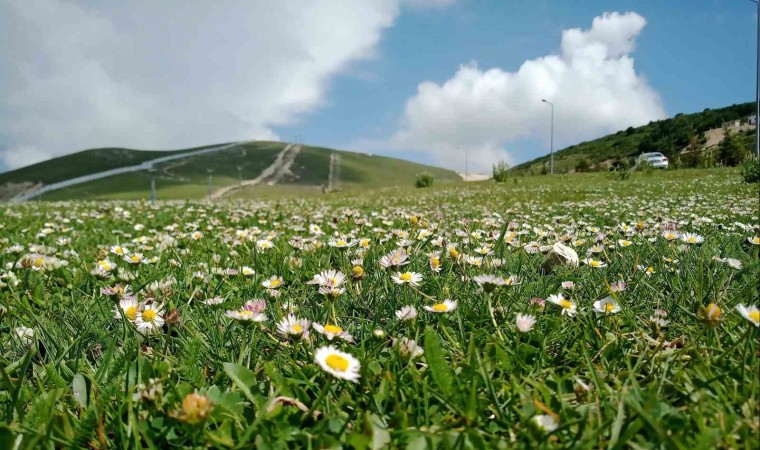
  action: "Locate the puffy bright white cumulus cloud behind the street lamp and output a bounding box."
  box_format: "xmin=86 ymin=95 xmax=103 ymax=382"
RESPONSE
xmin=389 ymin=12 xmax=665 ymax=170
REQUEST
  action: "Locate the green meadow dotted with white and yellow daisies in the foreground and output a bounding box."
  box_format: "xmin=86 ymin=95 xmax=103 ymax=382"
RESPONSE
xmin=0 ymin=169 xmax=760 ymax=449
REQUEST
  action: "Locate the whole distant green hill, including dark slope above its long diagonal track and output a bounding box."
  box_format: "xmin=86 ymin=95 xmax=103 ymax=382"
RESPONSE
xmin=0 ymin=141 xmax=460 ymax=201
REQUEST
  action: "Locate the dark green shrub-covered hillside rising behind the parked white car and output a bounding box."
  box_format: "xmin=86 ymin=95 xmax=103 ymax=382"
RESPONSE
xmin=511 ymin=102 xmax=755 ymax=174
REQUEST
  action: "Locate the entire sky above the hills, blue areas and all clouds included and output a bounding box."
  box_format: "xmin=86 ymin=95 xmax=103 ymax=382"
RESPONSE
xmin=0 ymin=0 xmax=756 ymax=171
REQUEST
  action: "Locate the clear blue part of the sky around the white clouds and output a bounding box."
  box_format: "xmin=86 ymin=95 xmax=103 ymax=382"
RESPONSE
xmin=275 ymin=0 xmax=756 ymax=169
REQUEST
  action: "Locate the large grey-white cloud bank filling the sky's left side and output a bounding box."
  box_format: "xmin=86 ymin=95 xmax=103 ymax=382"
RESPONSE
xmin=0 ymin=0 xmax=399 ymax=168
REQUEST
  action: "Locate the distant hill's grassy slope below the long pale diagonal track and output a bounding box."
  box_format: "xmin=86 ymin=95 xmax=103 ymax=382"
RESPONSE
xmin=25 ymin=142 xmax=461 ymax=201
